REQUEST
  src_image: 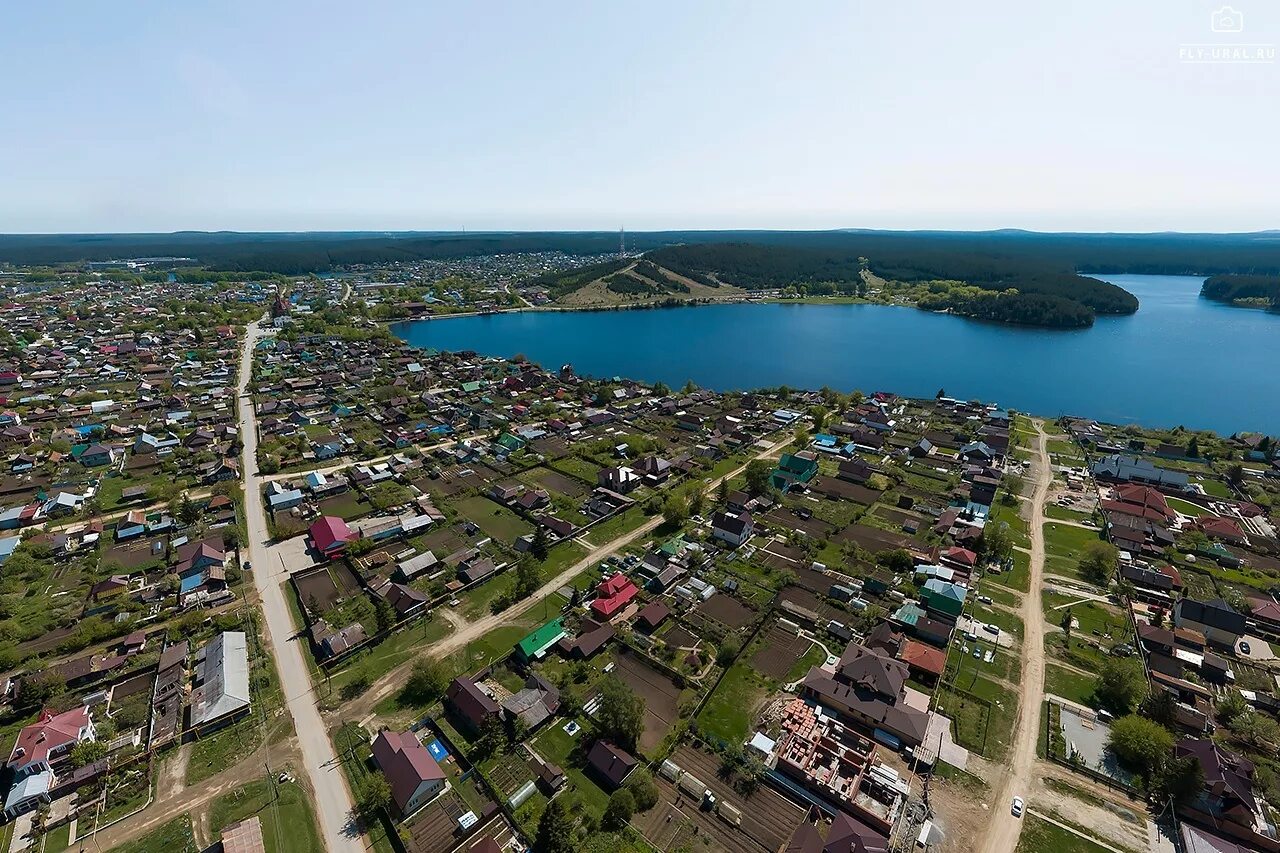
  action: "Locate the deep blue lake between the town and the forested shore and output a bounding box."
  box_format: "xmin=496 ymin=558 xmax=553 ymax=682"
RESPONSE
xmin=392 ymin=275 xmax=1280 ymax=434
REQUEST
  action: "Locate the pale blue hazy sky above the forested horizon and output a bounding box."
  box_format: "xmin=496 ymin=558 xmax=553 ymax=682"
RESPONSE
xmin=0 ymin=0 xmax=1280 ymax=232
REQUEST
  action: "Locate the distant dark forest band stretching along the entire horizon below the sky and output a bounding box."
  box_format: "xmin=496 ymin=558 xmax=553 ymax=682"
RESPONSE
xmin=0 ymin=231 xmax=1280 ymax=275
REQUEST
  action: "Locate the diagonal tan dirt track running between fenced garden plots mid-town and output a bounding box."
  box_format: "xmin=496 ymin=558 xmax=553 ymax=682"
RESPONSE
xmin=334 ymin=438 xmax=788 ymax=717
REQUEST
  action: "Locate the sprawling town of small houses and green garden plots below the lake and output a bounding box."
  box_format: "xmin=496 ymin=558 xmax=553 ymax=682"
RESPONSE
xmin=0 ymin=261 xmax=1280 ymax=853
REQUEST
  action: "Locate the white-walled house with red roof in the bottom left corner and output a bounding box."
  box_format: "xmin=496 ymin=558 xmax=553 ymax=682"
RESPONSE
xmin=4 ymin=706 xmax=96 ymax=818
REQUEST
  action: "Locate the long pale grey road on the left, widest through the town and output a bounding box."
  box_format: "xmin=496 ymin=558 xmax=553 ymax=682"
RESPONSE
xmin=238 ymin=323 xmax=365 ymax=853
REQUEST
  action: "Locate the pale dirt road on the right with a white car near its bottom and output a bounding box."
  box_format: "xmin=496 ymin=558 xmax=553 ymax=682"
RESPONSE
xmin=982 ymin=420 xmax=1053 ymax=853
